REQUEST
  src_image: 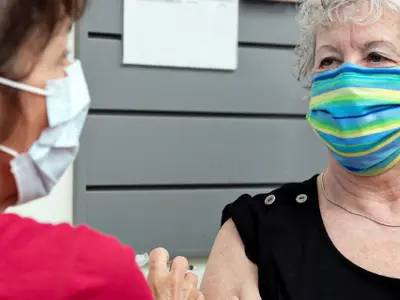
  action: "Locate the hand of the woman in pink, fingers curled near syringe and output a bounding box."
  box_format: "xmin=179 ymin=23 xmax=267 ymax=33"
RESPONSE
xmin=147 ymin=248 xmax=204 ymax=300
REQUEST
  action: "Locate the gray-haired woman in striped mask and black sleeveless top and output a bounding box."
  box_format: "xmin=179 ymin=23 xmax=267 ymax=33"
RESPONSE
xmin=202 ymin=0 xmax=400 ymax=300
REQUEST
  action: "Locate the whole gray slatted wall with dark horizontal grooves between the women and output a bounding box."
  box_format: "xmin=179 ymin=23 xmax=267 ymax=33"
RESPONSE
xmin=74 ymin=0 xmax=326 ymax=257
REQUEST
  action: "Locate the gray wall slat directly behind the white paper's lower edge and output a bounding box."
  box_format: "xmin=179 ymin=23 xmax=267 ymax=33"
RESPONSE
xmin=80 ymin=40 xmax=307 ymax=113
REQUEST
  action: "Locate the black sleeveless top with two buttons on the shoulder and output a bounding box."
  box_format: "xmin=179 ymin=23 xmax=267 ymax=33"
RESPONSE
xmin=222 ymin=175 xmax=400 ymax=300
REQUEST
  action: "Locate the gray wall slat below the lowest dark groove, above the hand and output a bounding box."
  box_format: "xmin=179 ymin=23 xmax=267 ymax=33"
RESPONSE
xmin=86 ymin=189 xmax=274 ymax=257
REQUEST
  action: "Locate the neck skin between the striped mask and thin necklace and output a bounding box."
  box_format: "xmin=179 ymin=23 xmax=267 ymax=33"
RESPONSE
xmin=324 ymin=158 xmax=400 ymax=220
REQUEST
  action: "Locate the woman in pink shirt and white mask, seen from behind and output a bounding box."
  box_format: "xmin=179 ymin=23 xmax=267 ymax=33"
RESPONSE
xmin=0 ymin=0 xmax=202 ymax=300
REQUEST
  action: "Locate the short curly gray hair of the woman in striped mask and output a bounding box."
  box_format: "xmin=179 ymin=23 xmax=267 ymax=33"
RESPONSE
xmin=295 ymin=0 xmax=400 ymax=81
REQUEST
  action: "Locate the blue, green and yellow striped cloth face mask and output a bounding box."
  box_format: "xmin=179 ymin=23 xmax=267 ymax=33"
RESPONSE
xmin=307 ymin=63 xmax=400 ymax=176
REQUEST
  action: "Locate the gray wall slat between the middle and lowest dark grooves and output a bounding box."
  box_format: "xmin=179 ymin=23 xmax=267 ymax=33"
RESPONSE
xmin=82 ymin=116 xmax=326 ymax=186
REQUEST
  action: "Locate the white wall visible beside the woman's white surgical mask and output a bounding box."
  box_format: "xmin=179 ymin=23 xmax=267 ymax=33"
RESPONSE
xmin=7 ymin=30 xmax=75 ymax=224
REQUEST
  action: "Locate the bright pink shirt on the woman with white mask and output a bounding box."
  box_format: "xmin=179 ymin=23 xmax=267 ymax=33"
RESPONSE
xmin=0 ymin=214 xmax=152 ymax=300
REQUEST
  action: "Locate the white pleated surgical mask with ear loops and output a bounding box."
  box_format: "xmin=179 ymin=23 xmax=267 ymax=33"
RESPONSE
xmin=0 ymin=61 xmax=90 ymax=204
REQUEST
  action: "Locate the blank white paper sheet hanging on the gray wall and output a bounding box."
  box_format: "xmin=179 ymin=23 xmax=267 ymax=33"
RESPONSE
xmin=123 ymin=0 xmax=239 ymax=70
